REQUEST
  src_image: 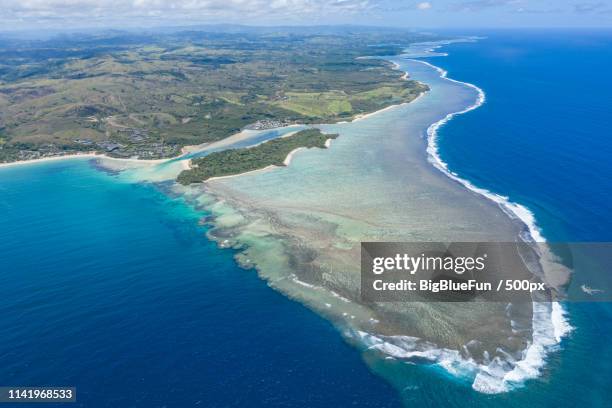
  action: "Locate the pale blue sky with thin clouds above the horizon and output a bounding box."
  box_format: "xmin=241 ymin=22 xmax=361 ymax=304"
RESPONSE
xmin=0 ymin=0 xmax=612 ymax=31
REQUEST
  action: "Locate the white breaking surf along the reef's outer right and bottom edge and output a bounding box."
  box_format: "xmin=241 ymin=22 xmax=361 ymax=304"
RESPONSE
xmin=357 ymin=47 xmax=573 ymax=394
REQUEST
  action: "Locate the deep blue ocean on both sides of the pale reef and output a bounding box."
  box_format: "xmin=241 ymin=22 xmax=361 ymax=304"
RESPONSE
xmin=0 ymin=31 xmax=612 ymax=407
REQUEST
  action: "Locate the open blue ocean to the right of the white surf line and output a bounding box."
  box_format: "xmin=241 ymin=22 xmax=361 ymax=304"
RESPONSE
xmin=428 ymin=30 xmax=612 ymax=407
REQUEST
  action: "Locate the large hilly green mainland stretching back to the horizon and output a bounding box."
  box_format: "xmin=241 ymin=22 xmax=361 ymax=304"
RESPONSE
xmin=0 ymin=27 xmax=431 ymax=161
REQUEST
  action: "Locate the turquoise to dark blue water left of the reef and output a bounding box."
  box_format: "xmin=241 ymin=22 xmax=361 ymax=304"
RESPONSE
xmin=0 ymin=160 xmax=400 ymax=407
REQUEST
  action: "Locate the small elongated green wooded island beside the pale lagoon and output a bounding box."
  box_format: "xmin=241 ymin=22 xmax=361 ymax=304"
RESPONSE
xmin=177 ymin=129 xmax=338 ymax=184
